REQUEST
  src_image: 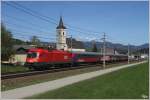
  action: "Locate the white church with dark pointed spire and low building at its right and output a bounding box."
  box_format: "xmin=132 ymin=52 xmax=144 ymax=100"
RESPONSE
xmin=56 ymin=17 xmax=85 ymax=52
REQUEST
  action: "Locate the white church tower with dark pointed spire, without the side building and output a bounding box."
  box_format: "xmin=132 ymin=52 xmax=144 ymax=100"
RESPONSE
xmin=56 ymin=17 xmax=68 ymax=50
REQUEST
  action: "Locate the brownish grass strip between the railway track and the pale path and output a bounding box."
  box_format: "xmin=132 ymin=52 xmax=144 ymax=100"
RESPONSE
xmin=1 ymin=62 xmax=143 ymax=91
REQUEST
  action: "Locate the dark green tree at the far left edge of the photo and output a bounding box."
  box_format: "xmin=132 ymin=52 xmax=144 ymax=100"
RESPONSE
xmin=1 ymin=24 xmax=14 ymax=61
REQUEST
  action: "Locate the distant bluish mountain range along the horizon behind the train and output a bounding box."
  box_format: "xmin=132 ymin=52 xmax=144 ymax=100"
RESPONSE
xmin=42 ymin=39 xmax=149 ymax=54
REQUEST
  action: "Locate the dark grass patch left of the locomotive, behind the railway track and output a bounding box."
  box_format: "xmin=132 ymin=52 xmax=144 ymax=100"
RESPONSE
xmin=1 ymin=65 xmax=29 ymax=74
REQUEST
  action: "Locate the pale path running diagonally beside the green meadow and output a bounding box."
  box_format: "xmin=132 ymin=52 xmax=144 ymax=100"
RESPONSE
xmin=1 ymin=61 xmax=146 ymax=99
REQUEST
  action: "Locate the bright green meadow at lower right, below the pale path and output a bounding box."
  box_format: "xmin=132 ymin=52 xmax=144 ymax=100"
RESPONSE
xmin=29 ymin=63 xmax=149 ymax=99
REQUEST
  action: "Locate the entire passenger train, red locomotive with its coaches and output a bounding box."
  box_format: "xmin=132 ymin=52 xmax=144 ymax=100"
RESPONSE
xmin=25 ymin=48 xmax=128 ymax=70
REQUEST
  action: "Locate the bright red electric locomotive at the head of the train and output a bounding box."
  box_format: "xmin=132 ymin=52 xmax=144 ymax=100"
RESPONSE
xmin=25 ymin=49 xmax=72 ymax=69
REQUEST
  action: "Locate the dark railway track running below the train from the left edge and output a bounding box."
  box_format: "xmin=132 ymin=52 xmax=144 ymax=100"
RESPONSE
xmin=1 ymin=64 xmax=101 ymax=80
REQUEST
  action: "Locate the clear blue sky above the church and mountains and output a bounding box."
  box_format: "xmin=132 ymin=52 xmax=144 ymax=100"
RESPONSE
xmin=2 ymin=1 xmax=148 ymax=45
